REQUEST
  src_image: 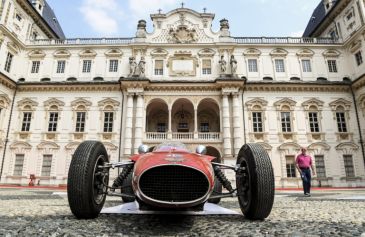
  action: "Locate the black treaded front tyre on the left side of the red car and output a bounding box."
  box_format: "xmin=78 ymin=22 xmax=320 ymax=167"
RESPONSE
xmin=67 ymin=141 xmax=109 ymax=219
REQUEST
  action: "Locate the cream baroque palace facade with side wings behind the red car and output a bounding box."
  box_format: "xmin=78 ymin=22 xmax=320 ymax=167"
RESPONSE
xmin=0 ymin=0 xmax=365 ymax=187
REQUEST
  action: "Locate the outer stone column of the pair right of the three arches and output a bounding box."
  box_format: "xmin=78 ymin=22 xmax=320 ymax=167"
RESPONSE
xmin=233 ymin=92 xmax=244 ymax=155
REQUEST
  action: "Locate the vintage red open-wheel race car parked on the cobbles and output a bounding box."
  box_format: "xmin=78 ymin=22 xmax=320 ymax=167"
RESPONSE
xmin=67 ymin=141 xmax=274 ymax=220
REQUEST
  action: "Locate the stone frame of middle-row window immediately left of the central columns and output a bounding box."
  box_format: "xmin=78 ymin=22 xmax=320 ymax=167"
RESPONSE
xmin=98 ymin=98 xmax=120 ymax=141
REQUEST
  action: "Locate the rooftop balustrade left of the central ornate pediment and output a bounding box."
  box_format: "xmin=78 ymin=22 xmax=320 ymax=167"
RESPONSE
xmin=28 ymin=38 xmax=133 ymax=45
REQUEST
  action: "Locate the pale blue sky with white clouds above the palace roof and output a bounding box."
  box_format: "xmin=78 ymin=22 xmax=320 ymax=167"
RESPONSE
xmin=47 ymin=0 xmax=320 ymax=38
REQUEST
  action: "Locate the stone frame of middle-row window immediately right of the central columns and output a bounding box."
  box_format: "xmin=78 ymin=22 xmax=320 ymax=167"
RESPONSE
xmin=246 ymin=98 xmax=268 ymax=142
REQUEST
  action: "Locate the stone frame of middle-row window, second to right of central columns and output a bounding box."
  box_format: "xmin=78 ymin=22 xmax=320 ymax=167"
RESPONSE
xmin=274 ymin=98 xmax=297 ymax=142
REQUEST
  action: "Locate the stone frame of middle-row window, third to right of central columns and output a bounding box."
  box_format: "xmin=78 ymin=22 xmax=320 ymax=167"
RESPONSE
xmin=302 ymin=98 xmax=326 ymax=142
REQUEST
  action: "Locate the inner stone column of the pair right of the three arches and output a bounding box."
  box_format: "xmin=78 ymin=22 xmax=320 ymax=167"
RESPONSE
xmin=222 ymin=93 xmax=232 ymax=158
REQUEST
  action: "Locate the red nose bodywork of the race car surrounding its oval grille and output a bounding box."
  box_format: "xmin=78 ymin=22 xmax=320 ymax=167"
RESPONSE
xmin=130 ymin=147 xmax=215 ymax=208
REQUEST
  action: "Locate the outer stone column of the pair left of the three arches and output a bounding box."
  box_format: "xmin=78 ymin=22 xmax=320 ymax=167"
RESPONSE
xmin=124 ymin=93 xmax=133 ymax=156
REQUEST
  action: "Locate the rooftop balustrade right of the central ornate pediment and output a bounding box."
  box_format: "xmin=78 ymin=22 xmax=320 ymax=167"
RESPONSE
xmin=234 ymin=37 xmax=341 ymax=44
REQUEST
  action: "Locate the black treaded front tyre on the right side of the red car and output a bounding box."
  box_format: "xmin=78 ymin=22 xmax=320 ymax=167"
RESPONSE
xmin=236 ymin=144 xmax=275 ymax=220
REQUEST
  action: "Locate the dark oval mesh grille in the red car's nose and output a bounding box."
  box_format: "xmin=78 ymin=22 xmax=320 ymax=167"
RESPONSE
xmin=139 ymin=165 xmax=209 ymax=202
